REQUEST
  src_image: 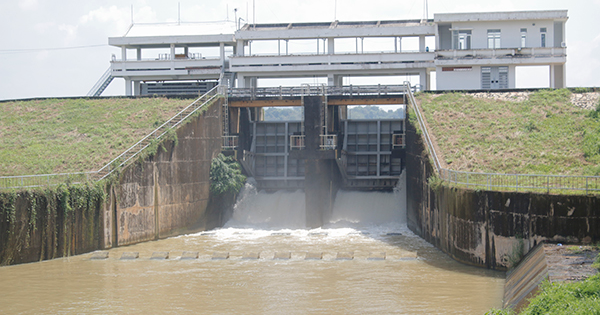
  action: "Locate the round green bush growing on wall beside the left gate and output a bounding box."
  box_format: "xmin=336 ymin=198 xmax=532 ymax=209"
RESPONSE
xmin=210 ymin=153 xmax=246 ymax=195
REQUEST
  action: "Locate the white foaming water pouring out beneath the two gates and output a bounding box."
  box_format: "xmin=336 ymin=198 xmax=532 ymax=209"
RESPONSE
xmin=215 ymin=173 xmax=412 ymax=239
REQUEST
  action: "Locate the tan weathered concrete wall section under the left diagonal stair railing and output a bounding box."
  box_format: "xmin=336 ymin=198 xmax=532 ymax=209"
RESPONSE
xmin=104 ymin=101 xmax=222 ymax=246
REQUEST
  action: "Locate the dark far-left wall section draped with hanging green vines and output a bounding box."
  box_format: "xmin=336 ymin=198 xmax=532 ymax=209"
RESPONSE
xmin=0 ymin=183 xmax=106 ymax=266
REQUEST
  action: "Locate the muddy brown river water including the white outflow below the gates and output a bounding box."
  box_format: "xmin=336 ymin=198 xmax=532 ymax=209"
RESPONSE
xmin=0 ymin=177 xmax=504 ymax=314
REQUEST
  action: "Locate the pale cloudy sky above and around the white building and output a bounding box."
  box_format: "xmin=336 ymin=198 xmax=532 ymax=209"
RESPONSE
xmin=0 ymin=0 xmax=600 ymax=100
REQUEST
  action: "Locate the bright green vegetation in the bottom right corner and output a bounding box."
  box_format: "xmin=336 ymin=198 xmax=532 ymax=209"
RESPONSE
xmin=487 ymin=274 xmax=600 ymax=315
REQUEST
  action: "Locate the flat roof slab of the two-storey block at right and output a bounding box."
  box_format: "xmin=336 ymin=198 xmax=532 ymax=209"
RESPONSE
xmin=433 ymin=10 xmax=569 ymax=23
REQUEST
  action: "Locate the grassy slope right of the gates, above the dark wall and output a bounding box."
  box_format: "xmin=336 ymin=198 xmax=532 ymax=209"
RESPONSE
xmin=417 ymin=90 xmax=600 ymax=175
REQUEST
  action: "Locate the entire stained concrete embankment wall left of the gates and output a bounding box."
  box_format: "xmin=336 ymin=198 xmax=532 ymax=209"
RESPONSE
xmin=0 ymin=101 xmax=225 ymax=265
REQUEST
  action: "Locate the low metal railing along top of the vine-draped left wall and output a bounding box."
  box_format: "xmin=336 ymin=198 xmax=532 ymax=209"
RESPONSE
xmin=0 ymin=171 xmax=98 ymax=189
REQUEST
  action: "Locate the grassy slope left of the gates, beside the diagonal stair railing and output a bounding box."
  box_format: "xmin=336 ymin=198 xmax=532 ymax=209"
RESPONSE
xmin=0 ymin=98 xmax=192 ymax=176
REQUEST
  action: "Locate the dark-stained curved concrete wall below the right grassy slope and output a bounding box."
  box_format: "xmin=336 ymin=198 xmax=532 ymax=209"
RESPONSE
xmin=406 ymin=117 xmax=600 ymax=270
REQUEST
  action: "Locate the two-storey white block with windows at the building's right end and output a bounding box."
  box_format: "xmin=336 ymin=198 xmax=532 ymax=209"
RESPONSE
xmin=434 ymin=10 xmax=567 ymax=90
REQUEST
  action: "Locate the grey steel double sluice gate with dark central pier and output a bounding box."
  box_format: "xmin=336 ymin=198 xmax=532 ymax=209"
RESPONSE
xmin=224 ymin=85 xmax=407 ymax=226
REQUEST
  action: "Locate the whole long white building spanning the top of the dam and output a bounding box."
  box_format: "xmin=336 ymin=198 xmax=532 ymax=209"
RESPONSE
xmin=98 ymin=10 xmax=568 ymax=95
